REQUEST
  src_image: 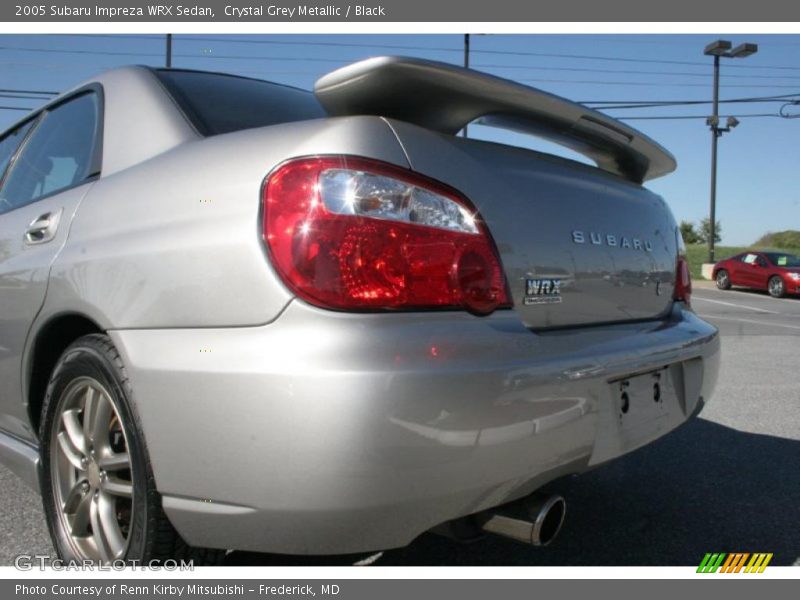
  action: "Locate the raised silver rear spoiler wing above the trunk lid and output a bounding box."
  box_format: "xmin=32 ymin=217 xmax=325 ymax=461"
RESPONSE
xmin=314 ymin=57 xmax=677 ymax=183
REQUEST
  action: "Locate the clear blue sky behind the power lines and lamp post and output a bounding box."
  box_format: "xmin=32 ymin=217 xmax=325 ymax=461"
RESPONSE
xmin=0 ymin=34 xmax=800 ymax=245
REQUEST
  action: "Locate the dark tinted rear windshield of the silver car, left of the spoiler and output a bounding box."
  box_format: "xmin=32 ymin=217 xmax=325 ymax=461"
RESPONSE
xmin=156 ymin=70 xmax=327 ymax=136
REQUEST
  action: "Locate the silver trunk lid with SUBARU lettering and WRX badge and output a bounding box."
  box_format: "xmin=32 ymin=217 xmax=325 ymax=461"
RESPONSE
xmin=390 ymin=121 xmax=678 ymax=329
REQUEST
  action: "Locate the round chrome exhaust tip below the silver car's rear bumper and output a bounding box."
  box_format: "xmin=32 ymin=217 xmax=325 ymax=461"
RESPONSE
xmin=481 ymin=495 xmax=567 ymax=546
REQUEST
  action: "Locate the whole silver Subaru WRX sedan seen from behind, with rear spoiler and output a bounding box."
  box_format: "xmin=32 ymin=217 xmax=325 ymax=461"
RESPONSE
xmin=0 ymin=58 xmax=719 ymax=563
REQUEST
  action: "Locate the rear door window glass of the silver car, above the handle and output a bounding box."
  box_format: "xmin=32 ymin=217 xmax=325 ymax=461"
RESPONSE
xmin=0 ymin=93 xmax=99 ymax=210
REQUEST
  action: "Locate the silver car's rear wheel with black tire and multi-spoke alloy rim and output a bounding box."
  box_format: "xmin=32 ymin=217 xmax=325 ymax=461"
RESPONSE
xmin=39 ymin=334 xmax=225 ymax=565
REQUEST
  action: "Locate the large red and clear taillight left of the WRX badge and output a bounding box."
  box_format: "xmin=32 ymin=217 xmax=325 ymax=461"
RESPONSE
xmin=263 ymin=156 xmax=509 ymax=314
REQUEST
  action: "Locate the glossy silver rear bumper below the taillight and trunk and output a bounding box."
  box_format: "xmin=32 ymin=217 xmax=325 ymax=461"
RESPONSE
xmin=110 ymin=302 xmax=719 ymax=554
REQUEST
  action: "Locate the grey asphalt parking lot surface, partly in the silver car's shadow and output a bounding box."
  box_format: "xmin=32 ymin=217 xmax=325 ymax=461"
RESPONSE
xmin=0 ymin=282 xmax=800 ymax=565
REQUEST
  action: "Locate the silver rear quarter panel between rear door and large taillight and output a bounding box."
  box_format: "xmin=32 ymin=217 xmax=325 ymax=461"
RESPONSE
xmin=40 ymin=117 xmax=408 ymax=329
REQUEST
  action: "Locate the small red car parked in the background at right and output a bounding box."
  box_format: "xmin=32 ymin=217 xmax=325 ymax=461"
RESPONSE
xmin=714 ymin=252 xmax=800 ymax=298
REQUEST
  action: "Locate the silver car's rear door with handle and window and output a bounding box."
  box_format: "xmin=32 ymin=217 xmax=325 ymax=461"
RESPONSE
xmin=0 ymin=91 xmax=102 ymax=439
